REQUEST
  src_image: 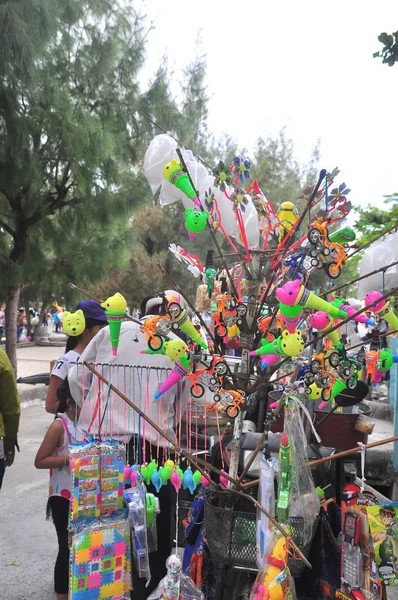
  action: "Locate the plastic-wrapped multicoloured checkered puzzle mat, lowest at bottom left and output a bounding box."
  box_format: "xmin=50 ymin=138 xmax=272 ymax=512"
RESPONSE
xmin=69 ymin=511 xmax=131 ymax=600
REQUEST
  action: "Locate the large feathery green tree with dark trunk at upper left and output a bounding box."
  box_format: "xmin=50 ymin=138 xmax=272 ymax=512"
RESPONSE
xmin=0 ymin=0 xmax=177 ymax=367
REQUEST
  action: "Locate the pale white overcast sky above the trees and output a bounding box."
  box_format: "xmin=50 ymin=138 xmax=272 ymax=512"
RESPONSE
xmin=142 ymin=0 xmax=398 ymax=211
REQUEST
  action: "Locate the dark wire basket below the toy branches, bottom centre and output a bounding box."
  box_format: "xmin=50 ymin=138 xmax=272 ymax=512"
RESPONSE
xmin=205 ymin=492 xmax=257 ymax=569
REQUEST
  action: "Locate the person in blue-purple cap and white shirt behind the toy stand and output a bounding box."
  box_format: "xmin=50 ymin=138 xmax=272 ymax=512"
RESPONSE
xmin=46 ymin=300 xmax=107 ymax=414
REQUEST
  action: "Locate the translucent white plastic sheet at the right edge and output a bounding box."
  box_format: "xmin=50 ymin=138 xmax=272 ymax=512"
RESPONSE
xmin=358 ymin=232 xmax=398 ymax=298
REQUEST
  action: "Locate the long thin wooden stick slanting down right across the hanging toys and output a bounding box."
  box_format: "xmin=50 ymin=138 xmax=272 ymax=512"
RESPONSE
xmin=83 ymin=361 xmax=312 ymax=569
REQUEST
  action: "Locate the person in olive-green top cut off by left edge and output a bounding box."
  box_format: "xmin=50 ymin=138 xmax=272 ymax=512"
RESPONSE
xmin=0 ymin=349 xmax=20 ymax=489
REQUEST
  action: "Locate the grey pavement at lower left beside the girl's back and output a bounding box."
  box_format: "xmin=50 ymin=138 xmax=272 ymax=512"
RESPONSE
xmin=0 ymin=406 xmax=57 ymax=600
